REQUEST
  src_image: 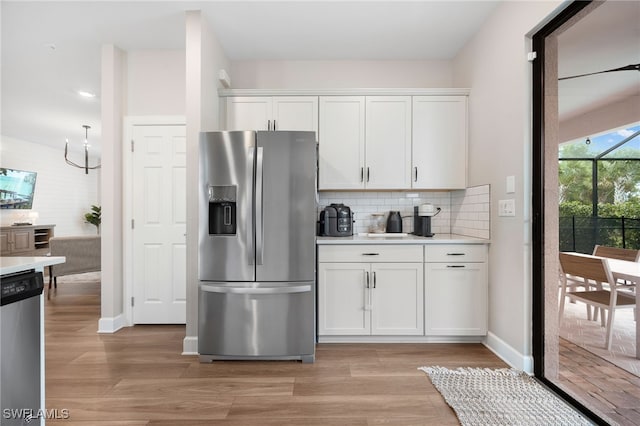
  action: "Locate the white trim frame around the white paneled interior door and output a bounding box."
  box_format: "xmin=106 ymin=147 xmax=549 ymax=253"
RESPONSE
xmin=122 ymin=115 xmax=187 ymax=327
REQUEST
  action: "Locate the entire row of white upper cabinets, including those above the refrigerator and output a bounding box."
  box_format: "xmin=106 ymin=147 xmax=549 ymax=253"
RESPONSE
xmin=226 ymin=91 xmax=468 ymax=190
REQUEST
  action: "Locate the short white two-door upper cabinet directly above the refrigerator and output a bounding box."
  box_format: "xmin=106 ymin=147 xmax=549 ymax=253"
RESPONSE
xmin=227 ymin=96 xmax=318 ymax=137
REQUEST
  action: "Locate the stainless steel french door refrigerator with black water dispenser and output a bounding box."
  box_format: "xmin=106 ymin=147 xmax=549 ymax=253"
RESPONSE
xmin=198 ymin=131 xmax=317 ymax=362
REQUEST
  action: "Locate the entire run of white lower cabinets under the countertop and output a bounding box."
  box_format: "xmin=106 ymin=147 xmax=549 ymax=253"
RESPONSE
xmin=317 ymin=244 xmax=488 ymax=342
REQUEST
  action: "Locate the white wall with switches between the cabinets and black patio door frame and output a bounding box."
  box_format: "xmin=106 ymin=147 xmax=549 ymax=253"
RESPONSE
xmin=453 ymin=1 xmax=560 ymax=371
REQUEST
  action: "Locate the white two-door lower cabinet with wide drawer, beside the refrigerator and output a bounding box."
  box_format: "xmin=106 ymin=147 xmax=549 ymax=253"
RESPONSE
xmin=318 ymin=246 xmax=424 ymax=336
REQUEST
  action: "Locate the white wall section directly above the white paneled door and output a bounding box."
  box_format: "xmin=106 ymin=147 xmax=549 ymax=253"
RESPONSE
xmin=127 ymin=49 xmax=186 ymax=116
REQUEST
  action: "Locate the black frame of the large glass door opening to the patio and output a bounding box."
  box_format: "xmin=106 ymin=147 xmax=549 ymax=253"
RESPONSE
xmin=531 ymin=0 xmax=606 ymax=424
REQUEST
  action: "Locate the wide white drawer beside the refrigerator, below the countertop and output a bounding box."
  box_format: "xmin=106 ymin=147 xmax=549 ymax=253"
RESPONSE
xmin=318 ymin=244 xmax=423 ymax=262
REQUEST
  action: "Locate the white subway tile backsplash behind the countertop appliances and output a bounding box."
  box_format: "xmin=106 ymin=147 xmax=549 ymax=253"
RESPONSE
xmin=318 ymin=185 xmax=490 ymax=238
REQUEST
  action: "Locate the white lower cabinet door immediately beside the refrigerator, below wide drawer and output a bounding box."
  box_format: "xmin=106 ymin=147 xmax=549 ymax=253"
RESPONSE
xmin=318 ymin=263 xmax=371 ymax=335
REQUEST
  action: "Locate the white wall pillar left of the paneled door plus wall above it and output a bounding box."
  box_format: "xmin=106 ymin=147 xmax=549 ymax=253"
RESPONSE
xmin=99 ymin=45 xmax=186 ymax=333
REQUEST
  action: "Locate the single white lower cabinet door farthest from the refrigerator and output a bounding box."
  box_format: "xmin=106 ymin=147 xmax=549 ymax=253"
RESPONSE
xmin=425 ymin=263 xmax=487 ymax=336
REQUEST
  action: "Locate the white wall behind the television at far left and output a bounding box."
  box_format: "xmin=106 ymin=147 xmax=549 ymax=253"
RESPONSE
xmin=0 ymin=136 xmax=100 ymax=237
